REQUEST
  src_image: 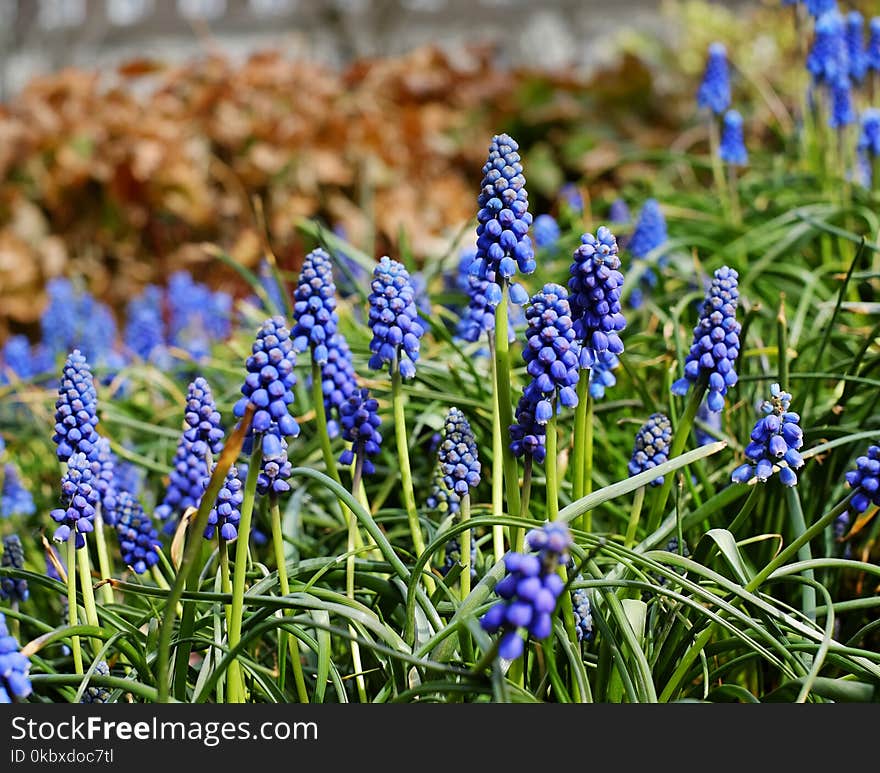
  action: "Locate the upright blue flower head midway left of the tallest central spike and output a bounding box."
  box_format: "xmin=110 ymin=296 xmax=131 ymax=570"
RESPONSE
xmin=291 ymin=247 xmax=339 ymax=365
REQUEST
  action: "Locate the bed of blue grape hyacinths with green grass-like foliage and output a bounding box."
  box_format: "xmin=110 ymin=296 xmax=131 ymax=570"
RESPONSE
xmin=0 ymin=1 xmax=880 ymax=703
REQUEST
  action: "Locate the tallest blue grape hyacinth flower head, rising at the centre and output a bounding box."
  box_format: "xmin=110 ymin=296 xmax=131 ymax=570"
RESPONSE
xmin=470 ymin=134 xmax=536 ymax=306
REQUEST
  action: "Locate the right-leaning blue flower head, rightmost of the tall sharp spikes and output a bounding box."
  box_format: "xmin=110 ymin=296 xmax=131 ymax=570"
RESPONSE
xmin=672 ymin=266 xmax=740 ymax=411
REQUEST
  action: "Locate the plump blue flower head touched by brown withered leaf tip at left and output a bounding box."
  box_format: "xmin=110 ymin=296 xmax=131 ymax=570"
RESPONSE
xmin=232 ymin=316 xmax=299 ymax=456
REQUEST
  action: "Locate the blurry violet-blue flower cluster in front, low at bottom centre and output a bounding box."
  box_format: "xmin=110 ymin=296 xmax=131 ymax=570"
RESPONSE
xmin=480 ymin=522 xmax=572 ymax=660
